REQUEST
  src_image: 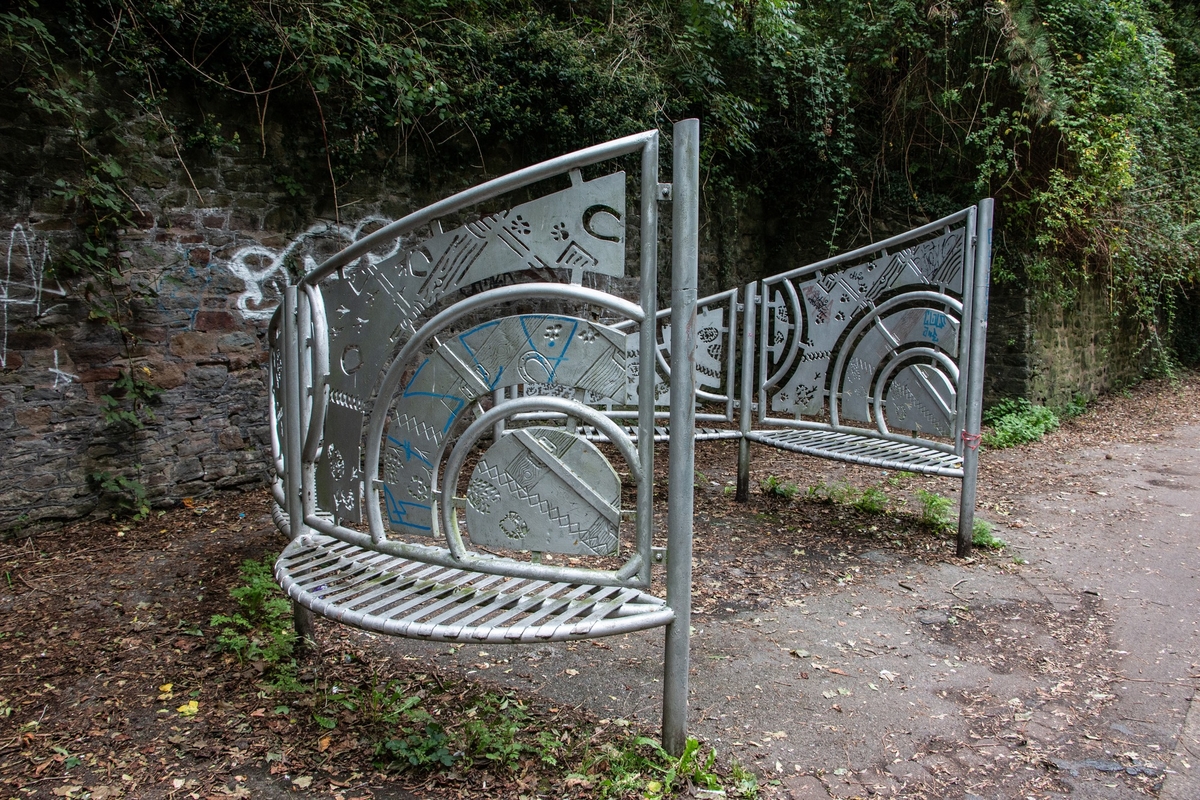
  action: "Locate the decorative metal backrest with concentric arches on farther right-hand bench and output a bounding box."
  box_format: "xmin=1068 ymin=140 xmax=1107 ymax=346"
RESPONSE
xmin=758 ymin=217 xmax=968 ymax=438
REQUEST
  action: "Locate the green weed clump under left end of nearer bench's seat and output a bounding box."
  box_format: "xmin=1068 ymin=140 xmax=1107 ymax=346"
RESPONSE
xmin=209 ymin=554 xmax=298 ymax=691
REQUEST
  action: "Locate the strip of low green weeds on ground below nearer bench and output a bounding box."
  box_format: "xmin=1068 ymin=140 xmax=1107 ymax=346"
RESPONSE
xmin=208 ymin=555 xmax=758 ymax=799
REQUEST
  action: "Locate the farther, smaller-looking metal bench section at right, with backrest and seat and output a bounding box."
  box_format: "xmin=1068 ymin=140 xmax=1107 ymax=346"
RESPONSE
xmin=535 ymin=199 xmax=992 ymax=555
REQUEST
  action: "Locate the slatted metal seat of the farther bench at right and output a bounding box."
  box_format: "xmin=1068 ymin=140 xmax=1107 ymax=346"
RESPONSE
xmin=746 ymin=428 xmax=962 ymax=477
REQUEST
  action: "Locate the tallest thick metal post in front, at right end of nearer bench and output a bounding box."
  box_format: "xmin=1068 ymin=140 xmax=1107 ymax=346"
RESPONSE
xmin=662 ymin=120 xmax=700 ymax=756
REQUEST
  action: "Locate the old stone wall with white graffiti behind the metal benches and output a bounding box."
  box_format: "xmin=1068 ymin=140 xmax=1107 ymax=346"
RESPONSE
xmin=0 ymin=115 xmax=1152 ymax=531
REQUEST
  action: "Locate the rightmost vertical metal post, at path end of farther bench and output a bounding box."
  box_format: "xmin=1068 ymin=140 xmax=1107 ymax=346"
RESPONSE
xmin=958 ymin=198 xmax=992 ymax=557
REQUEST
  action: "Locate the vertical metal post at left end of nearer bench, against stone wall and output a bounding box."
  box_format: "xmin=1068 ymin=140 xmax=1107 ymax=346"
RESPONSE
xmin=283 ymin=287 xmax=314 ymax=643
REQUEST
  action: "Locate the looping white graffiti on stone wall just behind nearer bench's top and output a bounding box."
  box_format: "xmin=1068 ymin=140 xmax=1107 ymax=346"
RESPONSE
xmin=218 ymin=217 xmax=400 ymax=319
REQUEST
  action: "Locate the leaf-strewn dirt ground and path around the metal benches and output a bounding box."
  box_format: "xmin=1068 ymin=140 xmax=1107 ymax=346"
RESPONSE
xmin=0 ymin=375 xmax=1200 ymax=800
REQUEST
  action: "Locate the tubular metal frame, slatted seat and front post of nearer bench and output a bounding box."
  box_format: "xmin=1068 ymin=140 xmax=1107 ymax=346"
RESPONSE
xmin=269 ymin=120 xmax=700 ymax=754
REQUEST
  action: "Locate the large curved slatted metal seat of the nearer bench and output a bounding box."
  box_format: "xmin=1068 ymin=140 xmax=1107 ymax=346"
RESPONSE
xmin=275 ymin=534 xmax=674 ymax=643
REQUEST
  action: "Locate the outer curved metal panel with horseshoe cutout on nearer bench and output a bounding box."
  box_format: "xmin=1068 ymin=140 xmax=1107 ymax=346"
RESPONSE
xmin=317 ymin=172 xmax=625 ymax=522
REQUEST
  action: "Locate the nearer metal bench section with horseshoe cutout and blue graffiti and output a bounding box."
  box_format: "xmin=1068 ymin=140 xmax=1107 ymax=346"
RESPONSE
xmin=269 ymin=120 xmax=698 ymax=753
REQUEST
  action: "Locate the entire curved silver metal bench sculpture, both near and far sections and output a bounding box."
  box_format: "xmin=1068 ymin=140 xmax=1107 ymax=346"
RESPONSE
xmin=269 ymin=120 xmax=991 ymax=753
